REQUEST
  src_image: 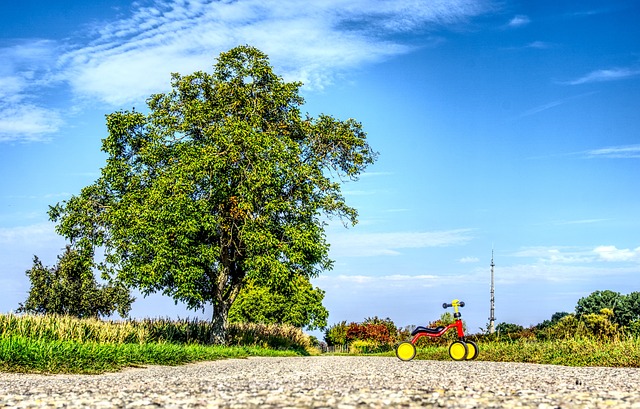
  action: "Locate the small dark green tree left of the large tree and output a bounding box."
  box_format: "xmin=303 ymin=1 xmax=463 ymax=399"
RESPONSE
xmin=17 ymin=247 xmax=134 ymax=318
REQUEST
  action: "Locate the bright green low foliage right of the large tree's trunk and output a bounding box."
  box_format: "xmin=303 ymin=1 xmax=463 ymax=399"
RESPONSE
xmin=229 ymin=277 xmax=329 ymax=330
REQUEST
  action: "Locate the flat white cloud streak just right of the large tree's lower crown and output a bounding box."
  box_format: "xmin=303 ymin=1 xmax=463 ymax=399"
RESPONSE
xmin=329 ymin=229 xmax=472 ymax=257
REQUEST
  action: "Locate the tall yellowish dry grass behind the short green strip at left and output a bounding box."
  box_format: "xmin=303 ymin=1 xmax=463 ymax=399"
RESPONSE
xmin=0 ymin=314 xmax=310 ymax=349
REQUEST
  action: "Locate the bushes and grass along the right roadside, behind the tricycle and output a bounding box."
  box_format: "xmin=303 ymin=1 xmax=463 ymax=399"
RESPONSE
xmin=322 ymin=290 xmax=640 ymax=368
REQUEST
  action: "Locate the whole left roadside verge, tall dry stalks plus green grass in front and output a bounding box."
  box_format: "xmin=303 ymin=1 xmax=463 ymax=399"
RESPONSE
xmin=0 ymin=314 xmax=315 ymax=374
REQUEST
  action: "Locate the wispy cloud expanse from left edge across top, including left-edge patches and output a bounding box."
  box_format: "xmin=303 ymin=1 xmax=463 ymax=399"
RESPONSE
xmin=0 ymin=0 xmax=491 ymax=142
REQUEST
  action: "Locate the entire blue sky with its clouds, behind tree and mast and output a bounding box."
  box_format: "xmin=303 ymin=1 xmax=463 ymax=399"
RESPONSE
xmin=0 ymin=0 xmax=640 ymax=332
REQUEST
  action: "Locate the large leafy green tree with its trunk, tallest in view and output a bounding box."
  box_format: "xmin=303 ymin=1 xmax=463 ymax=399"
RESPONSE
xmin=49 ymin=46 xmax=376 ymax=342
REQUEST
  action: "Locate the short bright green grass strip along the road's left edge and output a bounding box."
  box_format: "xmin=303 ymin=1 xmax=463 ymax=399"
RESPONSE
xmin=0 ymin=336 xmax=301 ymax=374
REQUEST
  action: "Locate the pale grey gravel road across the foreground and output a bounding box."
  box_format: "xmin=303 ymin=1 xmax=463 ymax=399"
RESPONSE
xmin=0 ymin=356 xmax=640 ymax=409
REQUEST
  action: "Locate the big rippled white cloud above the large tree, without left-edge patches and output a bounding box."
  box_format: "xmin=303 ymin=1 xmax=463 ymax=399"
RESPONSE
xmin=61 ymin=0 xmax=488 ymax=105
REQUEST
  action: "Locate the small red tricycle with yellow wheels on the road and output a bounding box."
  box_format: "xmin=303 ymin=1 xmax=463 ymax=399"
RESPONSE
xmin=396 ymin=300 xmax=478 ymax=361
